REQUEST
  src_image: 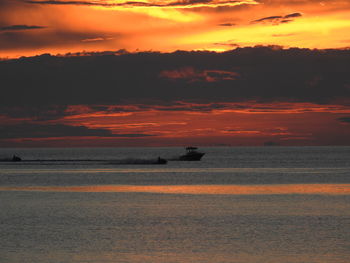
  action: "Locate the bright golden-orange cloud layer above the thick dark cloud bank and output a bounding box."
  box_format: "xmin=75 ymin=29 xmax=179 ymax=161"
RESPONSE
xmin=0 ymin=0 xmax=350 ymax=57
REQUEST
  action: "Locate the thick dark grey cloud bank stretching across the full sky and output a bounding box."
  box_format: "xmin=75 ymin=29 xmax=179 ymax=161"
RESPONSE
xmin=0 ymin=47 xmax=350 ymax=110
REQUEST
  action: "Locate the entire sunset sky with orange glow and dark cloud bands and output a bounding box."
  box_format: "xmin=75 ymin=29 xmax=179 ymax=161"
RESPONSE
xmin=0 ymin=0 xmax=350 ymax=147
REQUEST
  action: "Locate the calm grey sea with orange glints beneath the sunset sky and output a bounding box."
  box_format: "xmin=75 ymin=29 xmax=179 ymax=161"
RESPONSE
xmin=0 ymin=146 xmax=350 ymax=263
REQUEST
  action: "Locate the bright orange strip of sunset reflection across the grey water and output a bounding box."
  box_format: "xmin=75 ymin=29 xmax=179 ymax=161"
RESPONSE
xmin=0 ymin=184 xmax=350 ymax=195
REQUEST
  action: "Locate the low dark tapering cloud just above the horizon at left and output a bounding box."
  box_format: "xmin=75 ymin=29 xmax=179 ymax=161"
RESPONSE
xmin=0 ymin=123 xmax=152 ymax=139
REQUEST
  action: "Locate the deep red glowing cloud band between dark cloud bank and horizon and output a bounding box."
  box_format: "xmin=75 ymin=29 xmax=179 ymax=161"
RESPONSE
xmin=0 ymin=102 xmax=342 ymax=146
